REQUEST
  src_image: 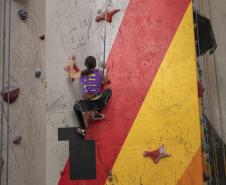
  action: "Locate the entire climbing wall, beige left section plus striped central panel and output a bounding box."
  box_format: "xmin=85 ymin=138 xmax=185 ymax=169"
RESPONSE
xmin=0 ymin=0 xmax=203 ymax=185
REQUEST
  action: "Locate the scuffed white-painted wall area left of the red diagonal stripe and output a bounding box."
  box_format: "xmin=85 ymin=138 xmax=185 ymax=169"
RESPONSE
xmin=46 ymin=0 xmax=128 ymax=185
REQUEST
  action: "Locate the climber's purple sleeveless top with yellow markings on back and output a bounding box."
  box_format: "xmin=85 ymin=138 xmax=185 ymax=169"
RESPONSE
xmin=80 ymin=69 xmax=103 ymax=95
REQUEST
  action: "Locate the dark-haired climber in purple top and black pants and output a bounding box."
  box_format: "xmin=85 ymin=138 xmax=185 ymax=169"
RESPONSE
xmin=74 ymin=56 xmax=112 ymax=135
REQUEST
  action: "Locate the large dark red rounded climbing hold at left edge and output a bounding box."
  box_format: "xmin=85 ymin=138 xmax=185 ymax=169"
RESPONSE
xmin=1 ymin=86 xmax=20 ymax=104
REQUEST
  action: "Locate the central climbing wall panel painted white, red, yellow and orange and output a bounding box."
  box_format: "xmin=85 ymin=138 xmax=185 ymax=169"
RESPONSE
xmin=50 ymin=0 xmax=203 ymax=185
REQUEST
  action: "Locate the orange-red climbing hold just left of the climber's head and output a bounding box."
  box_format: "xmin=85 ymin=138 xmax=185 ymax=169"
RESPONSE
xmin=64 ymin=56 xmax=81 ymax=81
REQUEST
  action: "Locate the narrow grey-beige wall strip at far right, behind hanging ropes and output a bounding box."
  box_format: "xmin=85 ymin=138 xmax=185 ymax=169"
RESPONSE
xmin=194 ymin=0 xmax=226 ymax=143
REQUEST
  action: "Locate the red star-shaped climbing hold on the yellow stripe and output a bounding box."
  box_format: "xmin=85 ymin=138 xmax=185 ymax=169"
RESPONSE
xmin=143 ymin=145 xmax=171 ymax=163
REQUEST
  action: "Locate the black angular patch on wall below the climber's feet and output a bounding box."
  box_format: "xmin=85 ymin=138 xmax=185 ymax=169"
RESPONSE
xmin=58 ymin=127 xmax=96 ymax=180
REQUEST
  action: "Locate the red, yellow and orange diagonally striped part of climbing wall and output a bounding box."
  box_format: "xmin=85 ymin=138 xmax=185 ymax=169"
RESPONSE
xmin=54 ymin=0 xmax=203 ymax=185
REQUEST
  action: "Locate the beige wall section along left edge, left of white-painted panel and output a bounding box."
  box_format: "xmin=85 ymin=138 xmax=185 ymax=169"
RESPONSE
xmin=0 ymin=0 xmax=46 ymax=185
